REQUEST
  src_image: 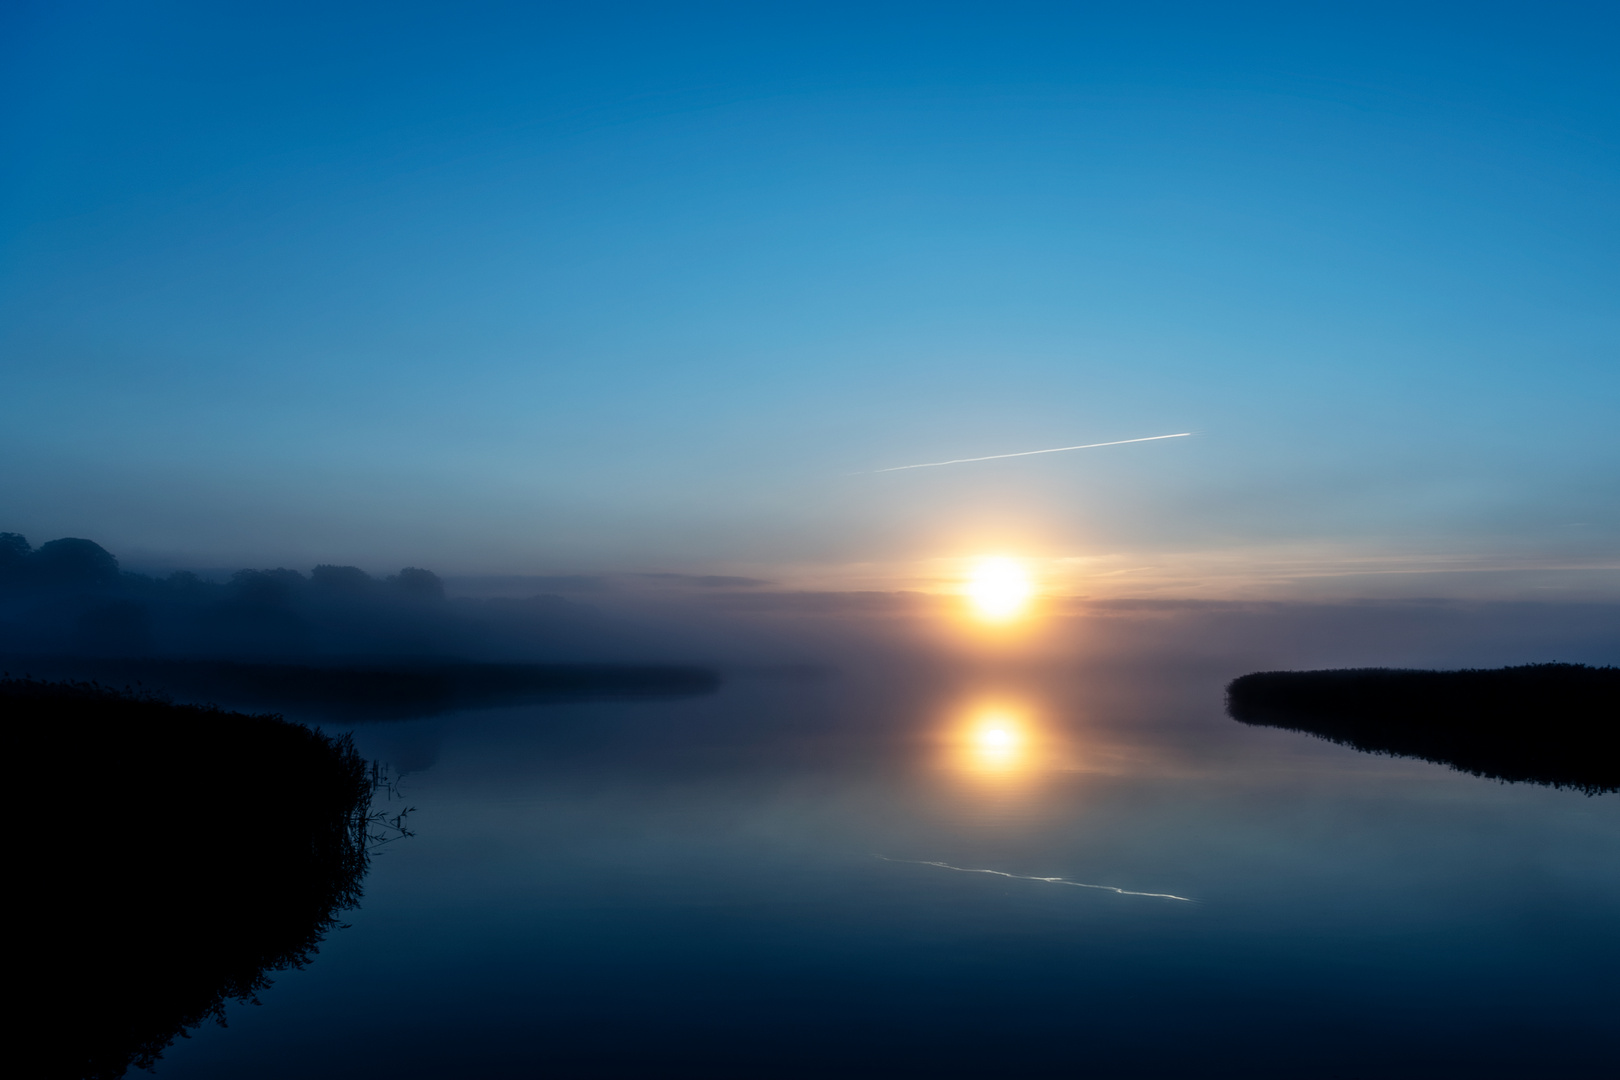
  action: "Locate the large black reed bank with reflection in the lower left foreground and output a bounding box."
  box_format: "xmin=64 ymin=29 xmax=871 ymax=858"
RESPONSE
xmin=0 ymin=678 xmax=377 ymax=1080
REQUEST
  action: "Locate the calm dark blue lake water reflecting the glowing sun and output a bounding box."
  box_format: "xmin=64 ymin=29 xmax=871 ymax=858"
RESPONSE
xmin=145 ymin=650 xmax=1620 ymax=1080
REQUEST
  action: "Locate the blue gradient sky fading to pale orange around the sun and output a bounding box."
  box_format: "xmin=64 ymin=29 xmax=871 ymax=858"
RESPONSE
xmin=0 ymin=2 xmax=1620 ymax=596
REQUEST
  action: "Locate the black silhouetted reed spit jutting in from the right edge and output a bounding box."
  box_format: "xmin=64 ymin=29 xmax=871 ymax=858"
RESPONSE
xmin=1226 ymin=664 xmax=1620 ymax=795
